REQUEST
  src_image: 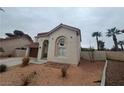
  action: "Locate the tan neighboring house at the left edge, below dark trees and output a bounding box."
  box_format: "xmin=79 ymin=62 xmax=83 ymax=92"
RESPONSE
xmin=0 ymin=36 xmax=33 ymax=56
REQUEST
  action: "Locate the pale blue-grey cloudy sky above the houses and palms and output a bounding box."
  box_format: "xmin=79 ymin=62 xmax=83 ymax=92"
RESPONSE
xmin=0 ymin=7 xmax=124 ymax=48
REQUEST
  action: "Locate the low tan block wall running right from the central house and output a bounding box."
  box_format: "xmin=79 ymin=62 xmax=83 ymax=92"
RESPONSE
xmin=81 ymin=51 xmax=124 ymax=61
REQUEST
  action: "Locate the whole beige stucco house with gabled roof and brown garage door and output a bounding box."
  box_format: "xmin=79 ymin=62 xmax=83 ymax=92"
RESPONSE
xmin=26 ymin=24 xmax=81 ymax=65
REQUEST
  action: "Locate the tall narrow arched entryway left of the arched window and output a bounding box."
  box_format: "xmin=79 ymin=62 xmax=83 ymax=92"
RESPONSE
xmin=41 ymin=40 xmax=49 ymax=59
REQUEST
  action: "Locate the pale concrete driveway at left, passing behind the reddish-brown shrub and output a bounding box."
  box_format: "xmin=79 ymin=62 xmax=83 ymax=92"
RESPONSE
xmin=0 ymin=57 xmax=36 ymax=67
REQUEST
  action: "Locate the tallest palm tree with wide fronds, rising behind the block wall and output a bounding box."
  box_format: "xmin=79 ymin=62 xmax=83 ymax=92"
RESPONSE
xmin=106 ymin=27 xmax=121 ymax=50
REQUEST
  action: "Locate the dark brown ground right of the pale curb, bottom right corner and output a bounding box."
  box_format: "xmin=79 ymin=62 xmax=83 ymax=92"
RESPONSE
xmin=106 ymin=60 xmax=124 ymax=86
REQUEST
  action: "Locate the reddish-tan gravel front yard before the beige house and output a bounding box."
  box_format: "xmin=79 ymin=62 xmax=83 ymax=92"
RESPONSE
xmin=0 ymin=60 xmax=105 ymax=86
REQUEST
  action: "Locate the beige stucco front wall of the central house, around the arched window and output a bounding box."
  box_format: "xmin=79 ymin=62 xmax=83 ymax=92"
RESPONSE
xmin=38 ymin=28 xmax=80 ymax=64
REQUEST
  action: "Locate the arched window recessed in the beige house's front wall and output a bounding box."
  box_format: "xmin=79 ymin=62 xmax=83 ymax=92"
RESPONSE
xmin=55 ymin=36 xmax=67 ymax=56
